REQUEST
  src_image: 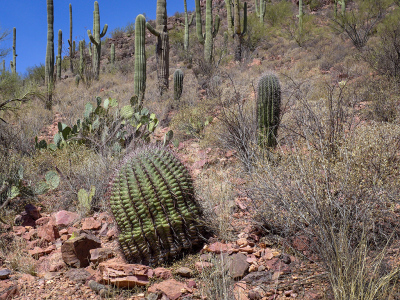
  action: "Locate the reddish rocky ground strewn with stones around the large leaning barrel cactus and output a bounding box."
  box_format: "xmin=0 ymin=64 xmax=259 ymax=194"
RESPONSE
xmin=0 ymin=140 xmax=332 ymax=300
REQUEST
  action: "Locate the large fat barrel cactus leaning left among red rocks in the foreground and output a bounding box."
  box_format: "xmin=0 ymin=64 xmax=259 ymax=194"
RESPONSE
xmin=110 ymin=147 xmax=202 ymax=265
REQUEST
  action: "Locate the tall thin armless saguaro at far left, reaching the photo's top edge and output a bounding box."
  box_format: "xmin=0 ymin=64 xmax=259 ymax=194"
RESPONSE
xmin=45 ymin=0 xmax=54 ymax=109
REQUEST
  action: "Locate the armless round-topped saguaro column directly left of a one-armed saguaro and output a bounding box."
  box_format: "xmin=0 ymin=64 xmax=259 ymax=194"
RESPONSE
xmin=133 ymin=15 xmax=146 ymax=106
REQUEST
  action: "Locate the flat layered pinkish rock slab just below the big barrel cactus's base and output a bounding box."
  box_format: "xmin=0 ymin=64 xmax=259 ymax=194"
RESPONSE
xmin=99 ymin=261 xmax=152 ymax=288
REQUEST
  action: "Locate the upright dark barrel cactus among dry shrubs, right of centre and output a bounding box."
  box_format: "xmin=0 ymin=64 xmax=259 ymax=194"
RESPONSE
xmin=257 ymin=74 xmax=281 ymax=147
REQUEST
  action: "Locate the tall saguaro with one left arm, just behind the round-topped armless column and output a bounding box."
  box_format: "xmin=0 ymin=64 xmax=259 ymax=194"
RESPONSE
xmin=146 ymin=0 xmax=169 ymax=95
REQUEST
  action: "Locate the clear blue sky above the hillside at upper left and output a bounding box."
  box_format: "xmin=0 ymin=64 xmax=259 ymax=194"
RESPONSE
xmin=0 ymin=0 xmax=194 ymax=74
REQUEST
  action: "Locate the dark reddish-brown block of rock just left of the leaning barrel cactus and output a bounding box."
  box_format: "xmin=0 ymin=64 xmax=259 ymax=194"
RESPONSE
xmin=61 ymin=233 xmax=101 ymax=268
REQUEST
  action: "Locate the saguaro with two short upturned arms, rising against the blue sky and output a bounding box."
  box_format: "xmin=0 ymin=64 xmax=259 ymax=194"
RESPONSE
xmin=88 ymin=1 xmax=108 ymax=80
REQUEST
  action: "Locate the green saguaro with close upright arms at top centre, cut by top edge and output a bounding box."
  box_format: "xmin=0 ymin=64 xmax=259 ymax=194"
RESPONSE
xmin=195 ymin=0 xmax=220 ymax=63
